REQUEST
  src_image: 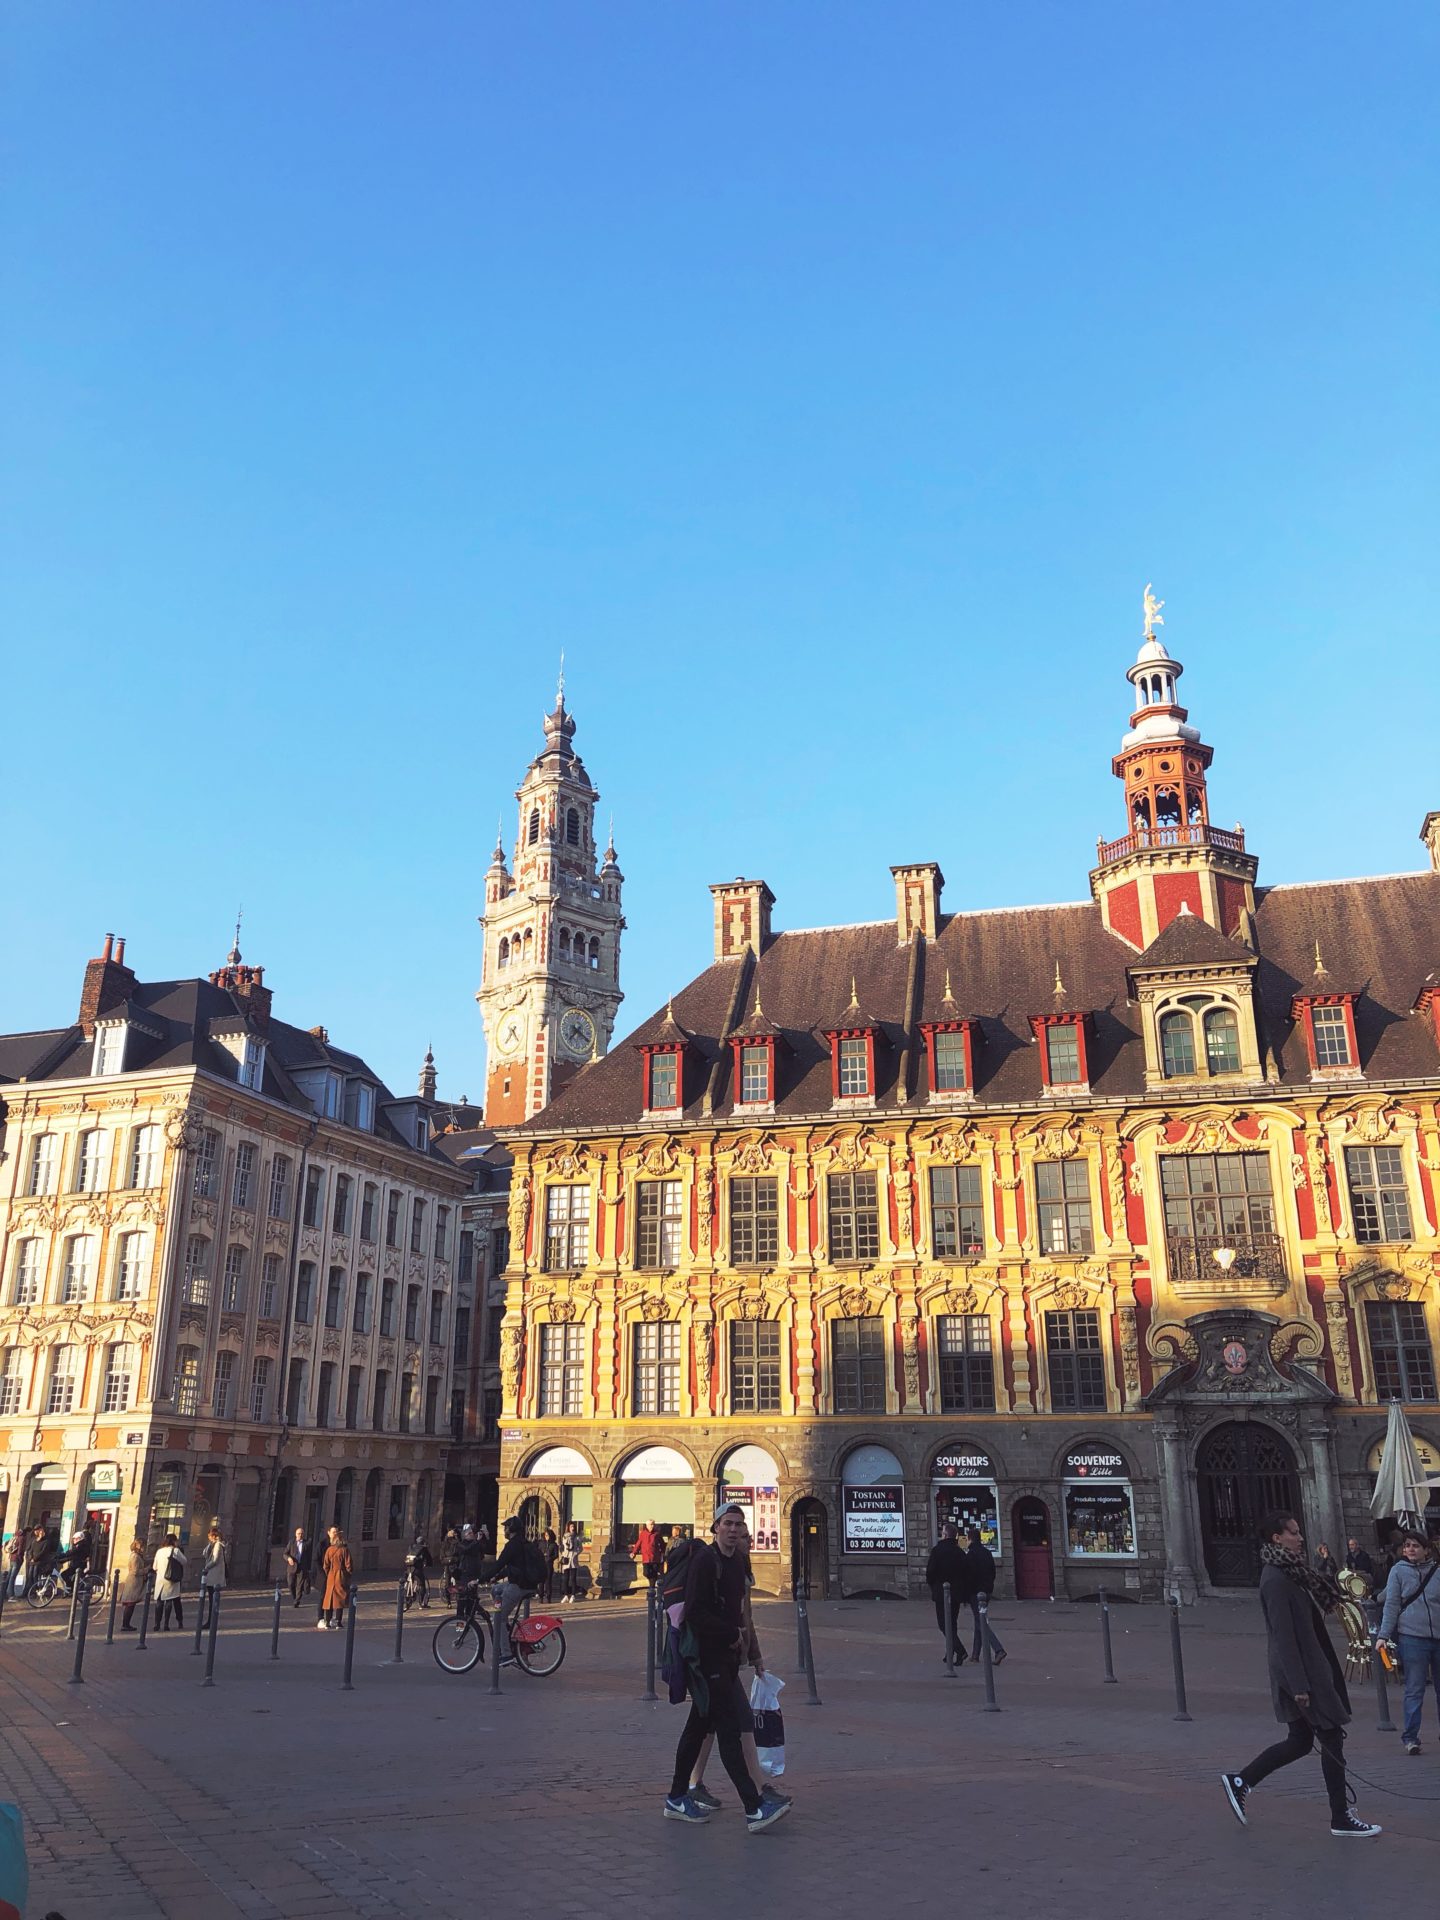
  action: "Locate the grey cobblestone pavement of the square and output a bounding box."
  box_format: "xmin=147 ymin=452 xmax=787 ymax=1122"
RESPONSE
xmin=0 ymin=1590 xmax=1440 ymax=1920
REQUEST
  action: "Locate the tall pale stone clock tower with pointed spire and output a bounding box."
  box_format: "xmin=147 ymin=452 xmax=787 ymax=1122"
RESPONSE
xmin=476 ymin=676 xmax=624 ymax=1127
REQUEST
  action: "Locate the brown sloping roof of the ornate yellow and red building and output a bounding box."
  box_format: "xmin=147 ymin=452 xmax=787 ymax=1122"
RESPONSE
xmin=507 ymin=874 xmax=1440 ymax=1133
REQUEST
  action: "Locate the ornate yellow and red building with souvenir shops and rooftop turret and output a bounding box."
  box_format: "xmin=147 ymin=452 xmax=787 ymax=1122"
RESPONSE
xmin=501 ymin=622 xmax=1440 ymax=1596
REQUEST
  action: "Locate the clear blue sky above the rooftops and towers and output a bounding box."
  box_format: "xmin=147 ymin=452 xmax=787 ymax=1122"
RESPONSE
xmin=0 ymin=0 xmax=1440 ymax=1096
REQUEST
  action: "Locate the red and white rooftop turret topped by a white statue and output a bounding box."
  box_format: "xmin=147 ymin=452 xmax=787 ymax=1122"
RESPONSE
xmin=1091 ymin=588 xmax=1260 ymax=952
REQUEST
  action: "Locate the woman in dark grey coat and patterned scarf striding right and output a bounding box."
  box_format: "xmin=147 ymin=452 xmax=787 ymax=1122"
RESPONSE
xmin=1219 ymin=1513 xmax=1380 ymax=1839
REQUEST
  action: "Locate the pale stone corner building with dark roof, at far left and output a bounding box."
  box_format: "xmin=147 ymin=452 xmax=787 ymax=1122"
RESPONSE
xmin=0 ymin=937 xmax=467 ymax=1574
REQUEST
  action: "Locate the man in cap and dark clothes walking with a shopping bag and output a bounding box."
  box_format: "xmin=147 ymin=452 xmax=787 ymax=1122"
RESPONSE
xmin=664 ymin=1501 xmax=791 ymax=1834
